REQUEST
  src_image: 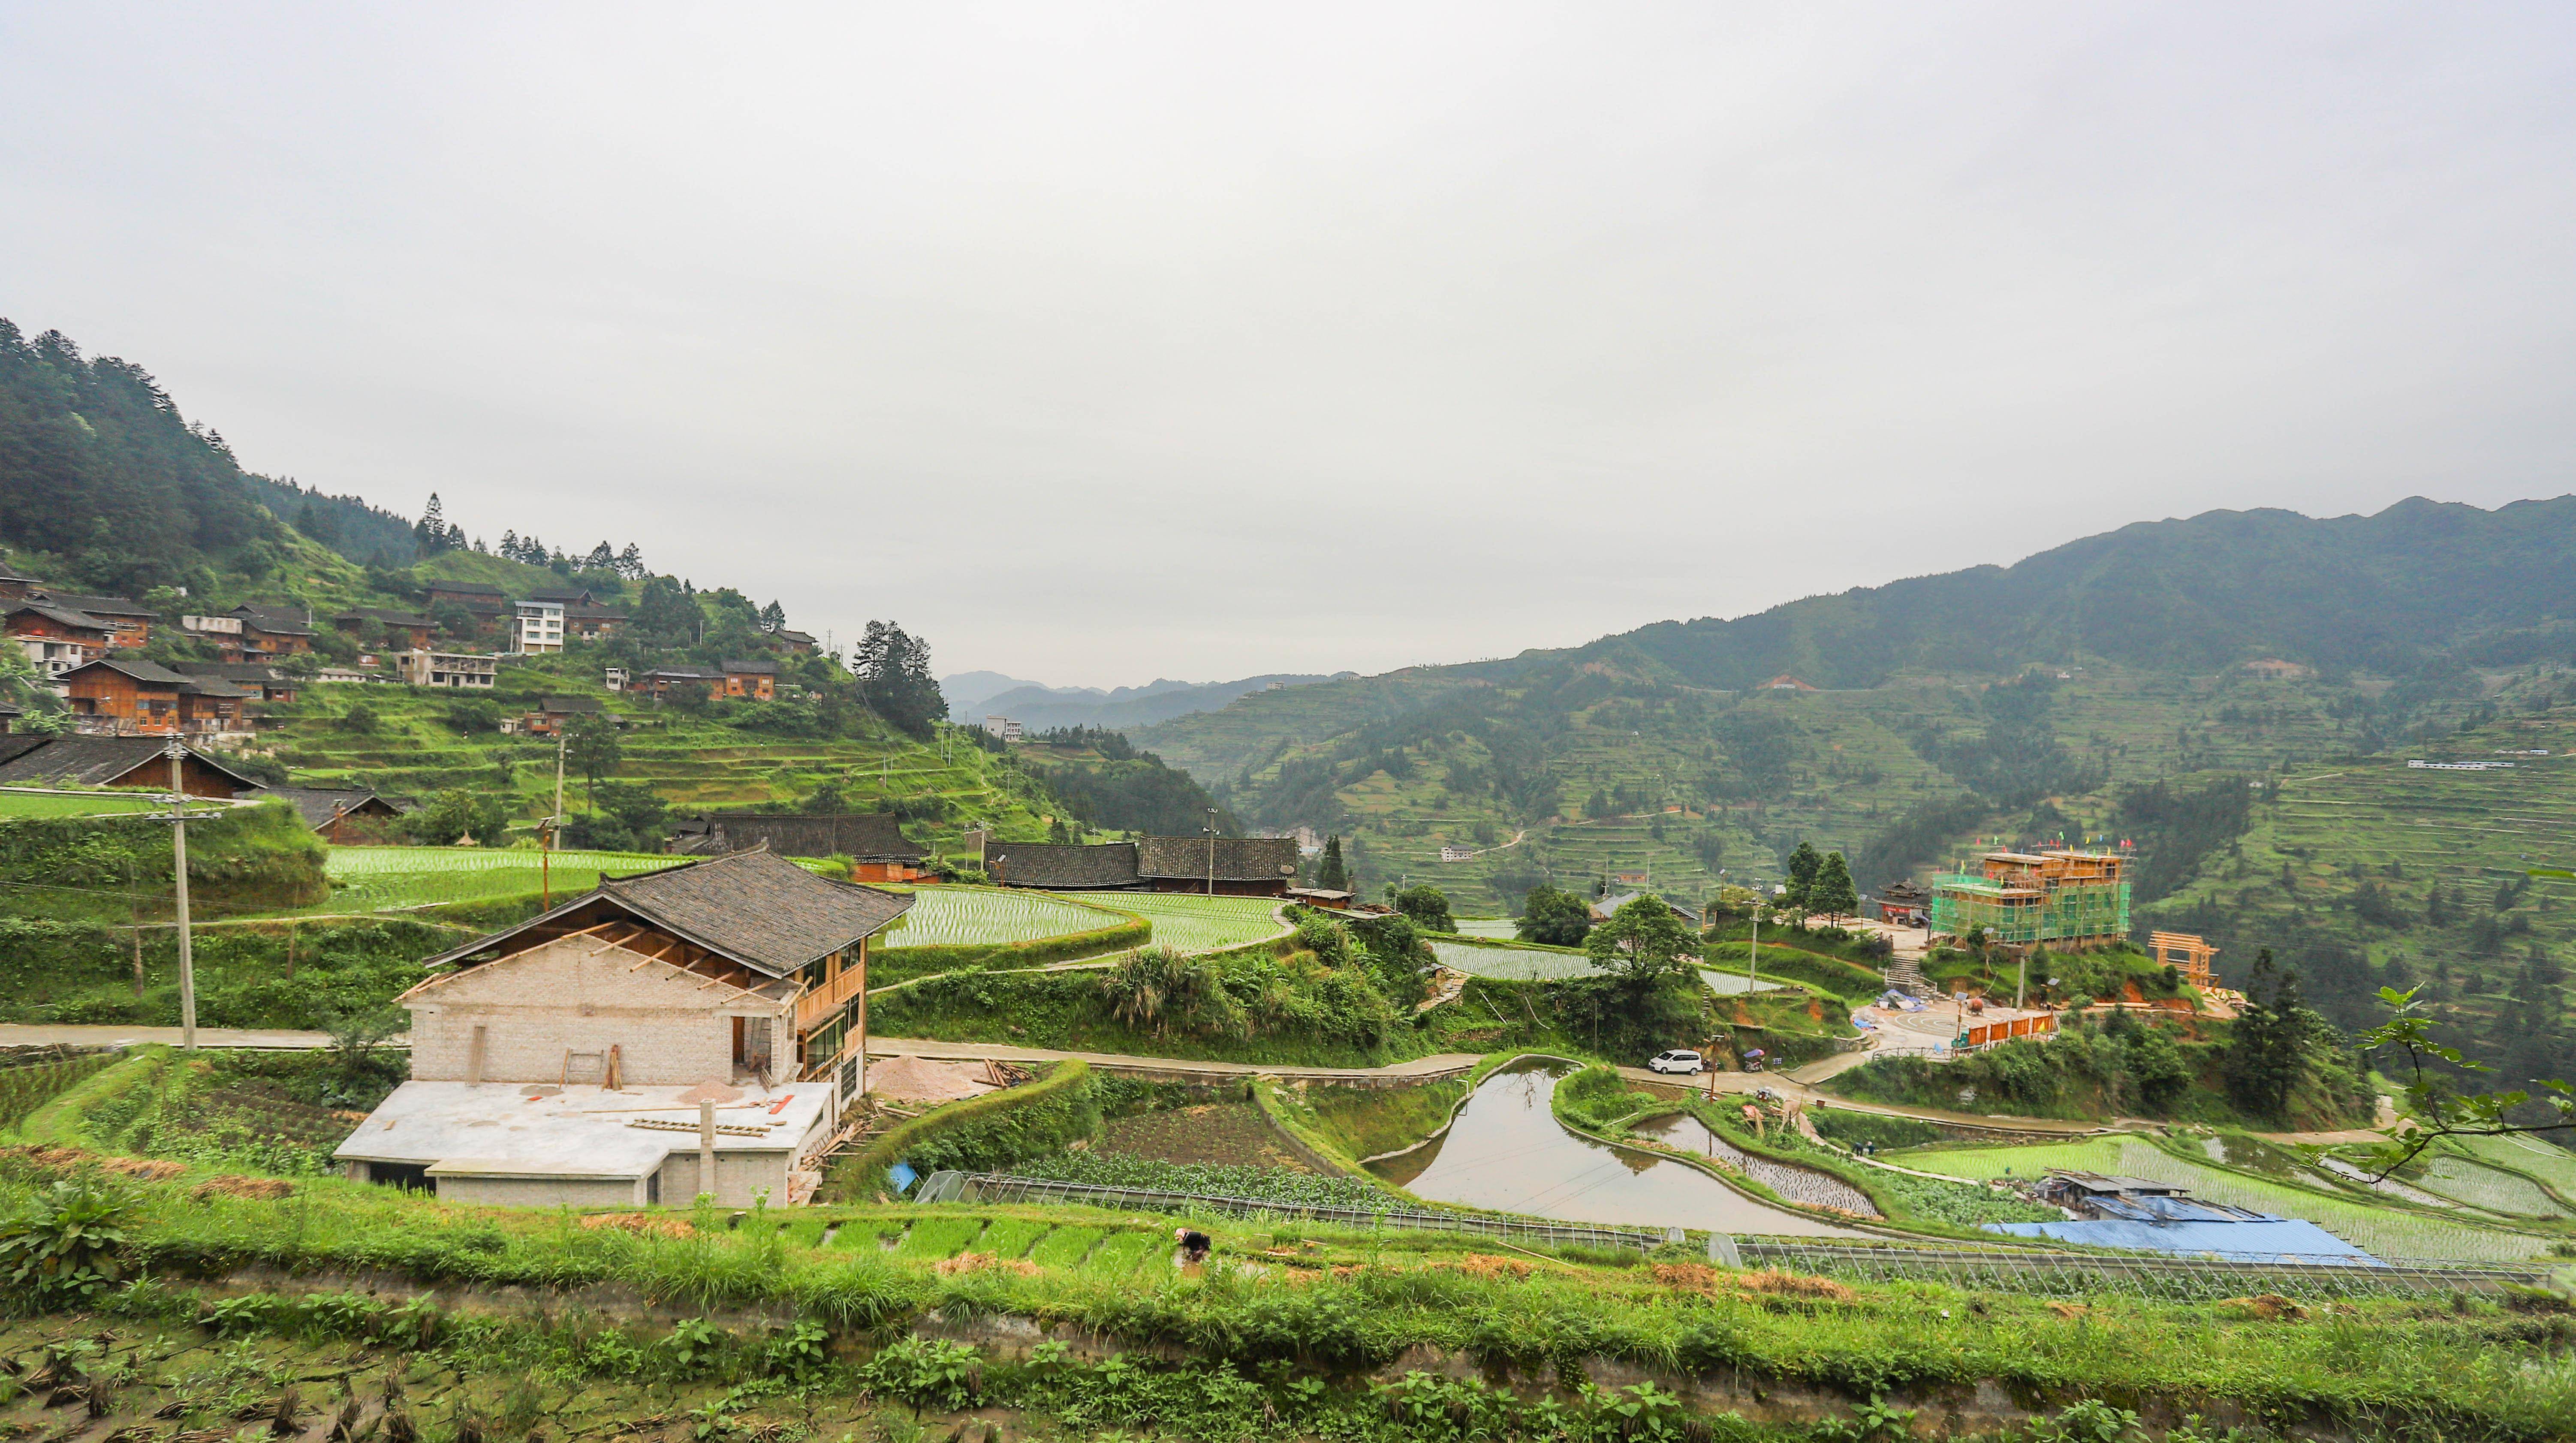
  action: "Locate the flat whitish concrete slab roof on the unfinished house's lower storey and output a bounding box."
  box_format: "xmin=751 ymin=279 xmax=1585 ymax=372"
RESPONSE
xmin=332 ymin=1080 xmax=832 ymax=1178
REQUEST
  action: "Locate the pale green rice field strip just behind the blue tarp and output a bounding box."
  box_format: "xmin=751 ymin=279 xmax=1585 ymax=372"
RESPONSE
xmin=1886 ymin=1136 xmax=2550 ymax=1262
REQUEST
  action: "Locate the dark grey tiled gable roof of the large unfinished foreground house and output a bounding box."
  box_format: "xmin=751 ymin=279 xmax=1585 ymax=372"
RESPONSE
xmin=425 ymin=853 xmax=912 ymax=976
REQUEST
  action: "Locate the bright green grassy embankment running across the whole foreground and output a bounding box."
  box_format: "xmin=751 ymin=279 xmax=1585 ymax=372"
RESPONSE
xmin=0 ymin=1139 xmax=2576 ymax=1438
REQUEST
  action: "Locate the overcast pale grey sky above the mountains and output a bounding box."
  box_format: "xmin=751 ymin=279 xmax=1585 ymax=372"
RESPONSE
xmin=0 ymin=0 xmax=2576 ymax=685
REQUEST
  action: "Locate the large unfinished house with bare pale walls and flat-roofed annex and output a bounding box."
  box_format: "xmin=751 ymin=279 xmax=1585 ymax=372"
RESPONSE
xmin=337 ymin=850 xmax=912 ymax=1208
